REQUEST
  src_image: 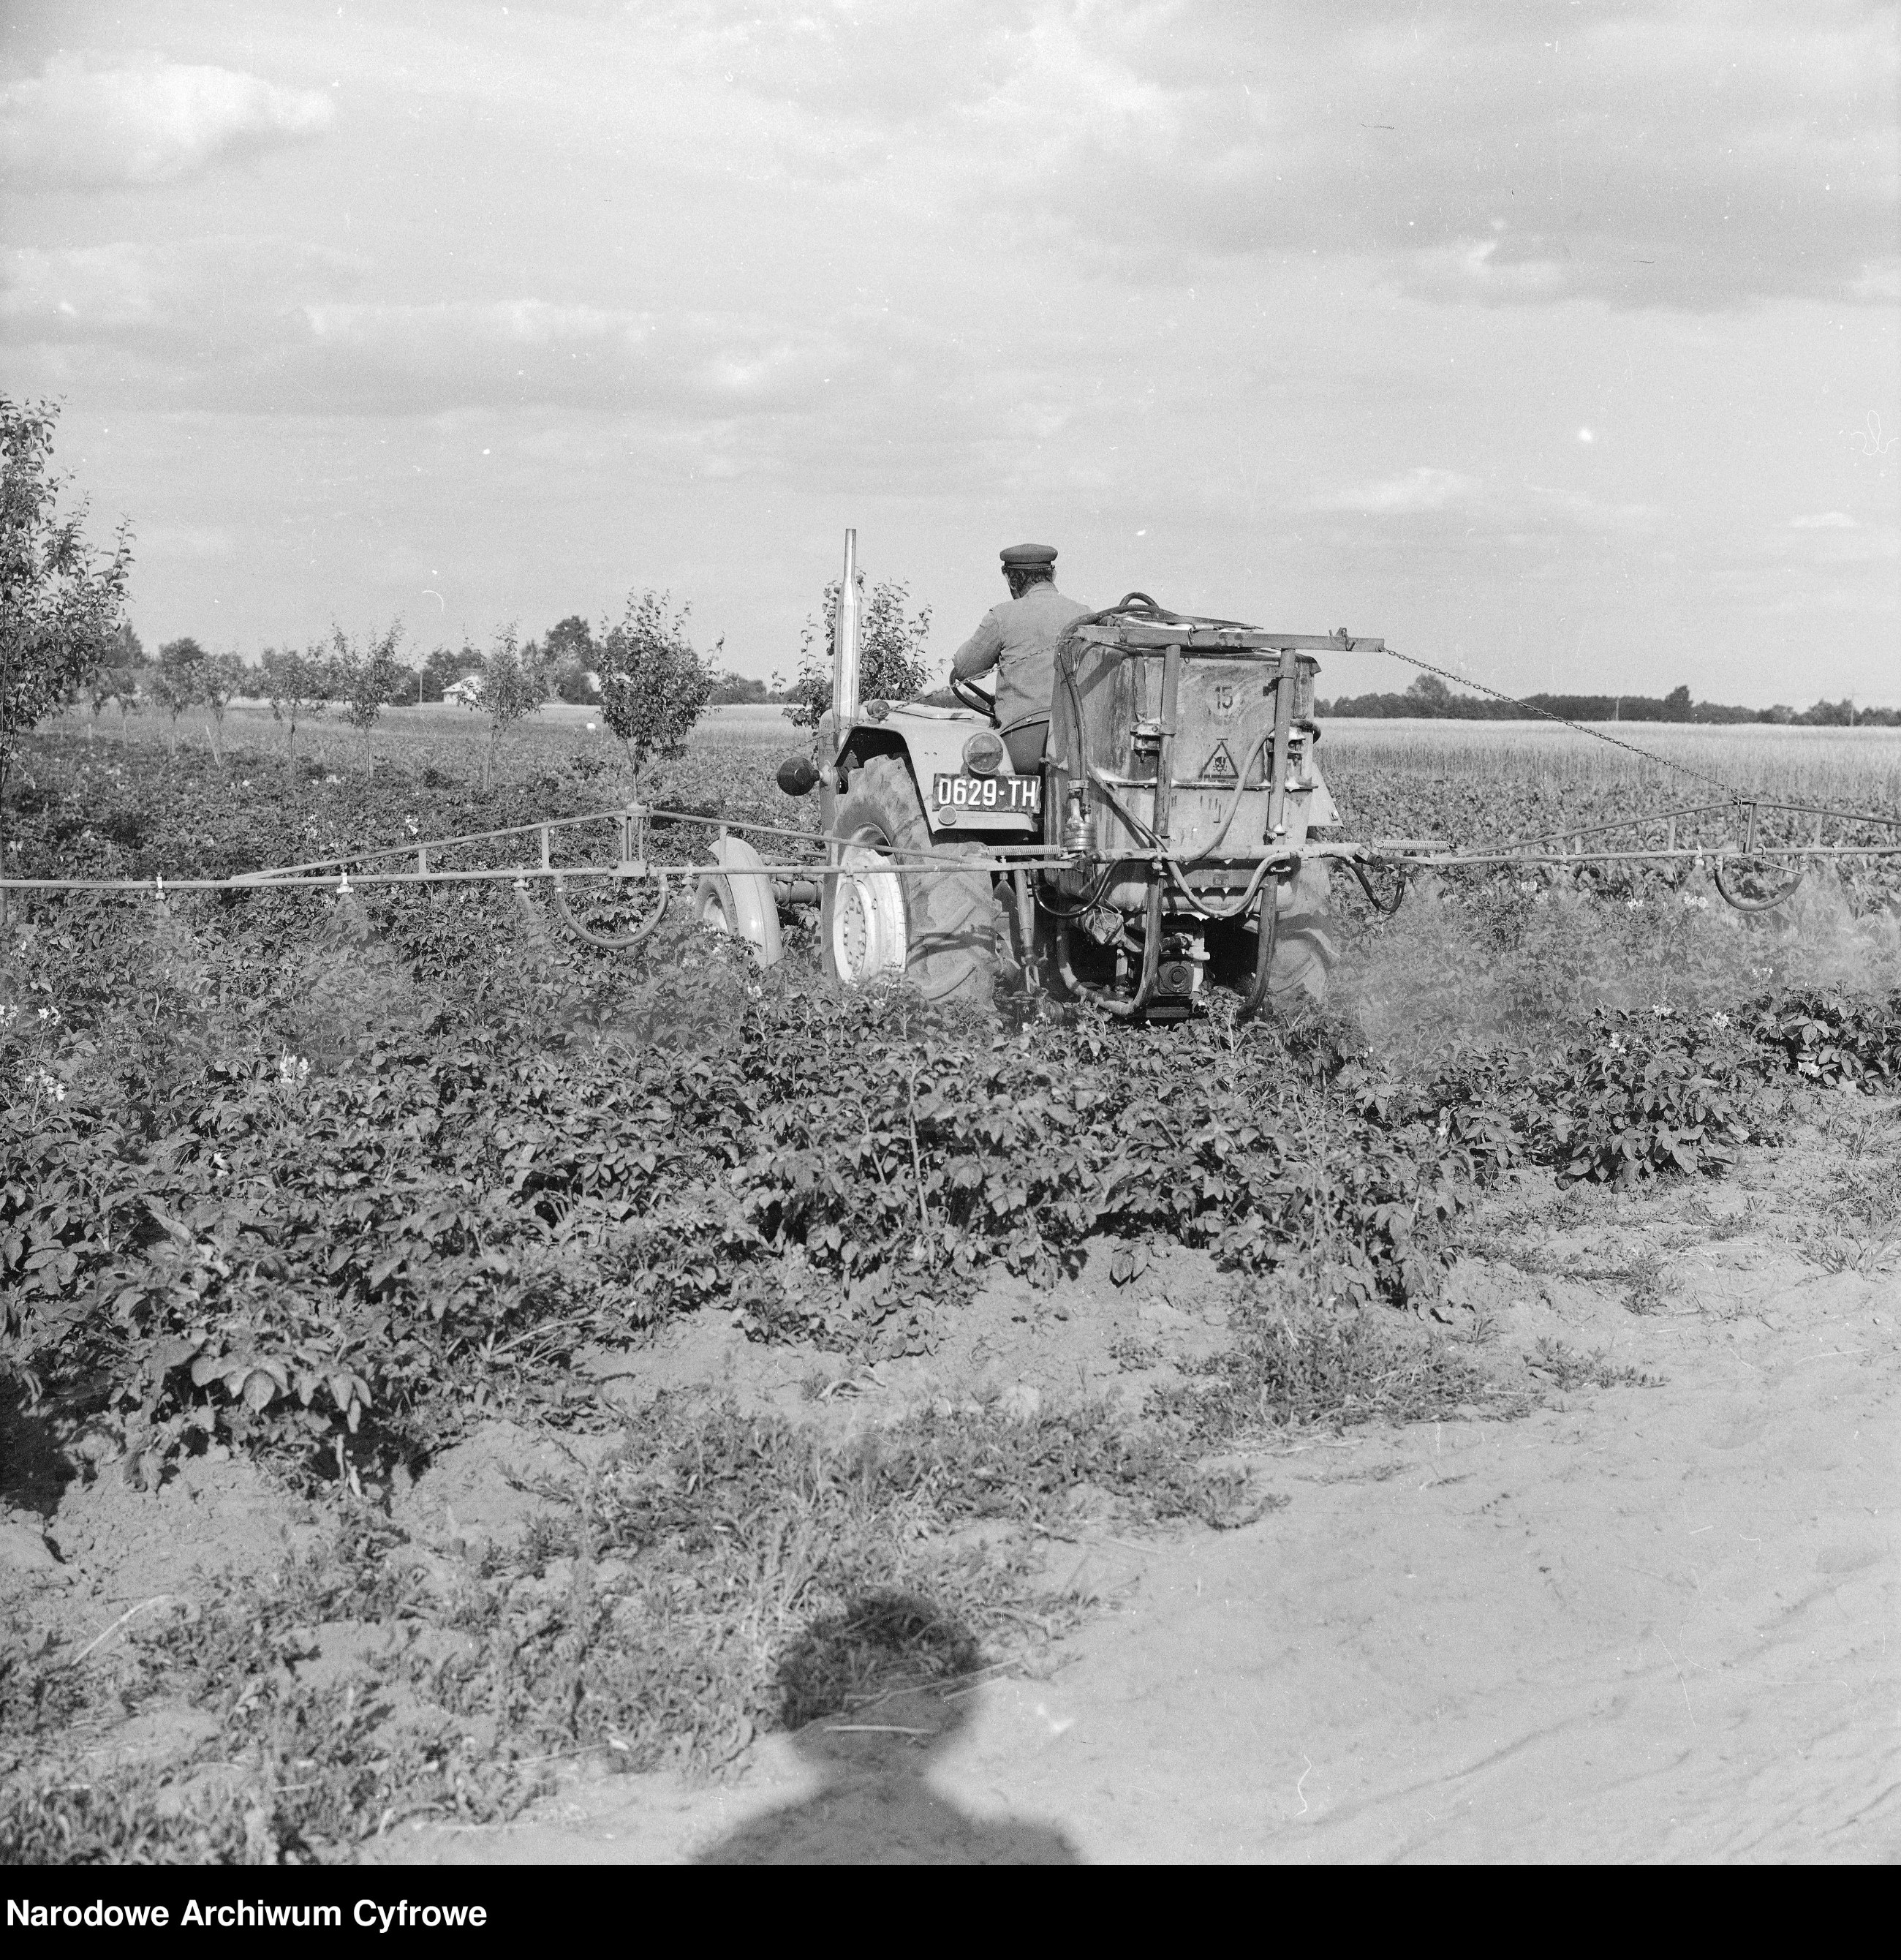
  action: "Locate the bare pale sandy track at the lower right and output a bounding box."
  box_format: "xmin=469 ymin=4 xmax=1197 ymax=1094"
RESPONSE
xmin=378 ymin=1153 xmax=1901 ymax=1862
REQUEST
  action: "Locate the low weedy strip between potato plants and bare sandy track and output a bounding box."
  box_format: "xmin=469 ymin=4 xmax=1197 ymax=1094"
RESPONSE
xmin=0 ymin=1400 xmax=1244 ymax=1862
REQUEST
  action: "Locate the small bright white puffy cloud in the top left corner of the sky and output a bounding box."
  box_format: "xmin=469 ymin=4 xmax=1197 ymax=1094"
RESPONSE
xmin=0 ymin=61 xmax=335 ymax=188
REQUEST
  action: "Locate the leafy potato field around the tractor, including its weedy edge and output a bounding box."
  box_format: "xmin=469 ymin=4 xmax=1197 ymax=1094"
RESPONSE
xmin=0 ymin=709 xmax=1901 ymax=1862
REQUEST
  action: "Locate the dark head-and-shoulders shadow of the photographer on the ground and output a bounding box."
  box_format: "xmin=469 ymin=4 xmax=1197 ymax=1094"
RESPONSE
xmin=700 ymin=1591 xmax=1078 ymax=1864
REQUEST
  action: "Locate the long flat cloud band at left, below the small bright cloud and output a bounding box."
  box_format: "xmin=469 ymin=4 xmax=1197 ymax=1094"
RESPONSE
xmin=0 ymin=235 xmax=980 ymax=475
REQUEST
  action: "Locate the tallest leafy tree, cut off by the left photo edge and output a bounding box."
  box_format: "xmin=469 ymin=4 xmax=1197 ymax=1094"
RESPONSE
xmin=0 ymin=394 xmax=132 ymax=796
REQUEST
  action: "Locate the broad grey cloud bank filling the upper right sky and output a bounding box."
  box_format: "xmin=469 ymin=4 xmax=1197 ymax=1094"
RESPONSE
xmin=721 ymin=0 xmax=1901 ymax=312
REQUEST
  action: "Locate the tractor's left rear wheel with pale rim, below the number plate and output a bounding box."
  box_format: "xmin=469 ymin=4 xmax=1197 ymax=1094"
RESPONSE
xmin=819 ymin=755 xmax=997 ymax=1008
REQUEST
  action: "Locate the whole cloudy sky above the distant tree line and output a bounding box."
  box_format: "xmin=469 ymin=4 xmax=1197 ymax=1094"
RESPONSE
xmin=0 ymin=0 xmax=1901 ymax=706
